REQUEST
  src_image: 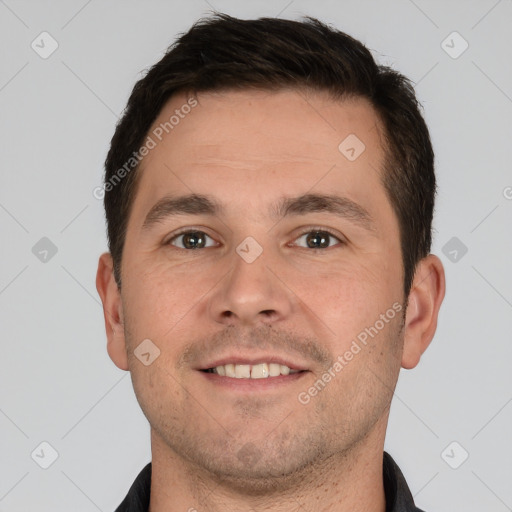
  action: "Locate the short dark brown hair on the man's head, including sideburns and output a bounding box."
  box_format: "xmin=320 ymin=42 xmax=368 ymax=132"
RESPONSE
xmin=104 ymin=14 xmax=436 ymax=298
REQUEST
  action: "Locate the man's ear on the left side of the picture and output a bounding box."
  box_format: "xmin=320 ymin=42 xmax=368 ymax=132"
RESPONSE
xmin=96 ymin=252 xmax=128 ymax=370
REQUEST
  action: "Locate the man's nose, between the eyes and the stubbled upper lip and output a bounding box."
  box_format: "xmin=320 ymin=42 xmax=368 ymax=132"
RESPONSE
xmin=209 ymin=245 xmax=294 ymax=326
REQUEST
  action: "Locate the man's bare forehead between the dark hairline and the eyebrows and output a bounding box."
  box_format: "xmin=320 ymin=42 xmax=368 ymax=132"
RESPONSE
xmin=134 ymin=90 xmax=384 ymax=222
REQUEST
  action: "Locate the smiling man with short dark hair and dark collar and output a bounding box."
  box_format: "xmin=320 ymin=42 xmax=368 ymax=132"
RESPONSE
xmin=96 ymin=15 xmax=445 ymax=512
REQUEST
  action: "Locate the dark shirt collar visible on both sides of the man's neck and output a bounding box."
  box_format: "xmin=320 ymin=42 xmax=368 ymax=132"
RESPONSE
xmin=116 ymin=452 xmax=422 ymax=512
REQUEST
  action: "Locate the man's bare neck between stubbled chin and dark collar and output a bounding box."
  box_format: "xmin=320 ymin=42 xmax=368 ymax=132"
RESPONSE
xmin=150 ymin=416 xmax=386 ymax=512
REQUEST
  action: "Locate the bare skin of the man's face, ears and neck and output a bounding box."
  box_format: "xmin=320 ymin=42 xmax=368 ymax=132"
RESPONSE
xmin=96 ymin=90 xmax=445 ymax=512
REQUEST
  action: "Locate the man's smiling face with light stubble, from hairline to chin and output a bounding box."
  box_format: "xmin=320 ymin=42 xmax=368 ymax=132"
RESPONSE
xmin=110 ymin=91 xmax=404 ymax=488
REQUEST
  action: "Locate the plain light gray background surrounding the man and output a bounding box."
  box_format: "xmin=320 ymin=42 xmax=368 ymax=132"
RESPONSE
xmin=0 ymin=0 xmax=512 ymax=512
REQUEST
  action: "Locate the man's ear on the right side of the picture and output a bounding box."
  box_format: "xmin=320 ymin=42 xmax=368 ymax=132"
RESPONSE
xmin=402 ymin=254 xmax=446 ymax=370
